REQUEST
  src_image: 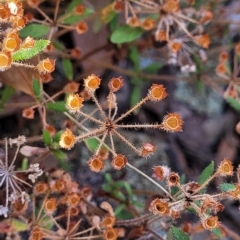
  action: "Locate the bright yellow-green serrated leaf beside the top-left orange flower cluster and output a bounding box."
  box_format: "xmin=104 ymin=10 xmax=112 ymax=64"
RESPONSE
xmin=12 ymin=39 xmax=50 ymax=61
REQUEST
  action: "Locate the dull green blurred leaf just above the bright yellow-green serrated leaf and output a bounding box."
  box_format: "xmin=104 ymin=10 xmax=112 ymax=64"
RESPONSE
xmin=20 ymin=23 xmax=50 ymax=38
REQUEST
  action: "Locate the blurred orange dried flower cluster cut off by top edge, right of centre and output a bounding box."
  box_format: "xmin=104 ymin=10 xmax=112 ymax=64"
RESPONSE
xmin=113 ymin=0 xmax=213 ymax=72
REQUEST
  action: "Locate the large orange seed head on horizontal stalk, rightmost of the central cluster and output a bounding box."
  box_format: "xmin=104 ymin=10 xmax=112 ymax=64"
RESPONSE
xmin=161 ymin=113 xmax=183 ymax=132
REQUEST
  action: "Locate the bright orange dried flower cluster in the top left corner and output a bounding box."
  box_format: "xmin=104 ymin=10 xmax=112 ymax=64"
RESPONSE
xmin=0 ymin=0 xmax=55 ymax=73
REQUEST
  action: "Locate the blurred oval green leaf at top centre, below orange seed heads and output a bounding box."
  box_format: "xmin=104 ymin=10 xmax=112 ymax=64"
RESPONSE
xmin=110 ymin=24 xmax=144 ymax=44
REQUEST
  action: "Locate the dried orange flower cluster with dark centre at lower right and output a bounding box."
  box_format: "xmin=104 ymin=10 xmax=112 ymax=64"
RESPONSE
xmin=149 ymin=159 xmax=240 ymax=230
